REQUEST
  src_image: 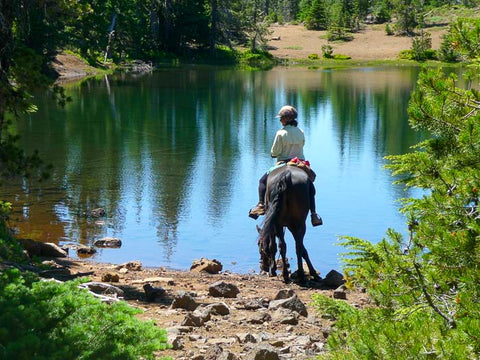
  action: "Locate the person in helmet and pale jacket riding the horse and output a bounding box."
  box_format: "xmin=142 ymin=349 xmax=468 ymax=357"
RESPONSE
xmin=248 ymin=105 xmax=323 ymax=226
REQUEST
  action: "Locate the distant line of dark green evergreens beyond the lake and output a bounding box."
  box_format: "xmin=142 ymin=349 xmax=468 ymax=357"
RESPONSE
xmin=0 ymin=0 xmax=478 ymax=67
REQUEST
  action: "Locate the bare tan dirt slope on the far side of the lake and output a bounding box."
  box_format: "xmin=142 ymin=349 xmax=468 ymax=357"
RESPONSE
xmin=268 ymin=24 xmax=445 ymax=61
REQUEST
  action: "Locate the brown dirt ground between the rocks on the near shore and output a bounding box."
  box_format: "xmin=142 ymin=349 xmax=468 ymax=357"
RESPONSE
xmin=49 ymin=259 xmax=368 ymax=360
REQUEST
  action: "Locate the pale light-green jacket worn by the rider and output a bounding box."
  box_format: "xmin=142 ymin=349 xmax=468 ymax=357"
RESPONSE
xmin=270 ymin=125 xmax=305 ymax=161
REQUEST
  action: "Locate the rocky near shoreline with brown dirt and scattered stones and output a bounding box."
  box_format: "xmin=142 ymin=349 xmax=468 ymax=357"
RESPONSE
xmin=3 ymin=239 xmax=368 ymax=360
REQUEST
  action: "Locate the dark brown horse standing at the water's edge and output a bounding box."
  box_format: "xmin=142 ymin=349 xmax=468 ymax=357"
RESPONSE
xmin=258 ymin=165 xmax=320 ymax=283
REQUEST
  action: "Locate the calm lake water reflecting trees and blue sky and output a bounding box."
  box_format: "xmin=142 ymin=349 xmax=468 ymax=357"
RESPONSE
xmin=0 ymin=67 xmax=432 ymax=275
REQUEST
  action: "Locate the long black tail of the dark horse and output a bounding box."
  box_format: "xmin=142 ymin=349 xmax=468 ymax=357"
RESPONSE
xmin=258 ymin=171 xmax=292 ymax=271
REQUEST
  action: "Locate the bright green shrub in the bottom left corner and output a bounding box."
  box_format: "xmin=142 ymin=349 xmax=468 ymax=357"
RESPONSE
xmin=0 ymin=270 xmax=167 ymax=360
